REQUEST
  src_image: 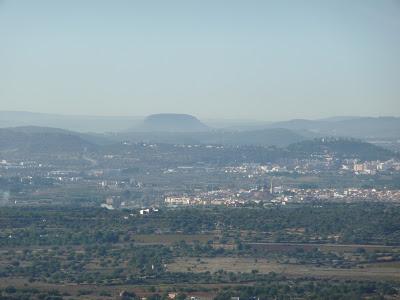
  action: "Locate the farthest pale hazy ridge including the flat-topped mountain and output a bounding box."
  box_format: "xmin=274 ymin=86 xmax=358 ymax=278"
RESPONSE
xmin=0 ymin=111 xmax=400 ymax=141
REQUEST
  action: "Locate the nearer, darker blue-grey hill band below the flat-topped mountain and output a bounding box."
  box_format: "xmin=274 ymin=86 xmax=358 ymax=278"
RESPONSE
xmin=0 ymin=126 xmax=399 ymax=160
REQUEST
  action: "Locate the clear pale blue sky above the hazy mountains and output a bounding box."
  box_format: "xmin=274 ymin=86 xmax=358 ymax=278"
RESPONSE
xmin=0 ymin=0 xmax=400 ymax=121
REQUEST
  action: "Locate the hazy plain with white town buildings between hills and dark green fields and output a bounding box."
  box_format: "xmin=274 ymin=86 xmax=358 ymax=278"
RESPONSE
xmin=0 ymin=140 xmax=400 ymax=209
